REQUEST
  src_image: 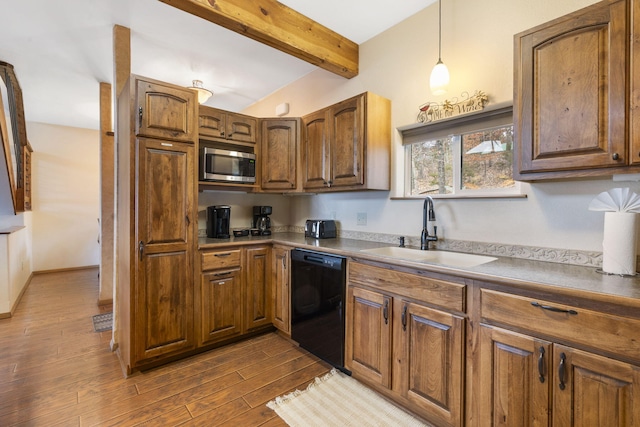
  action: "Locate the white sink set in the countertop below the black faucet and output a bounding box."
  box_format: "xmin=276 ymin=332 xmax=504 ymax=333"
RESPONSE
xmin=361 ymin=246 xmax=497 ymax=268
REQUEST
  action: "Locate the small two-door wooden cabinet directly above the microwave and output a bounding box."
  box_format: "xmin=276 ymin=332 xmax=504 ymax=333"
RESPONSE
xmin=198 ymin=105 xmax=258 ymax=144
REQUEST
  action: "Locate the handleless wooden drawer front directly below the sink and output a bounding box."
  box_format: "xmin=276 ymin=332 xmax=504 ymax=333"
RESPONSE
xmin=348 ymin=262 xmax=466 ymax=311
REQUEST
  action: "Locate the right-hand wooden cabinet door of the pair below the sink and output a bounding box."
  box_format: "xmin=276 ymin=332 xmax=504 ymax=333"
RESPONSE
xmin=393 ymin=300 xmax=465 ymax=426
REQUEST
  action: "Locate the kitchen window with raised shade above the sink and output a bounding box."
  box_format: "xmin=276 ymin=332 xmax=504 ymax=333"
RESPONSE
xmin=400 ymin=107 xmax=522 ymax=197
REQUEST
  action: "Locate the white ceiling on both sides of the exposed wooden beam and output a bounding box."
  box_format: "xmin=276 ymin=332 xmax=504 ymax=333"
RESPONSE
xmin=0 ymin=0 xmax=435 ymax=129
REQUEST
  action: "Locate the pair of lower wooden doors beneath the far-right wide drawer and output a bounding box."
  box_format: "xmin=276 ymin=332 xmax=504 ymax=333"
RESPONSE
xmin=480 ymin=325 xmax=640 ymax=427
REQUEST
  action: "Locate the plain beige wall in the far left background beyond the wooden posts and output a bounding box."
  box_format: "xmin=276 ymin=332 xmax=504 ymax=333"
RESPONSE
xmin=27 ymin=122 xmax=100 ymax=271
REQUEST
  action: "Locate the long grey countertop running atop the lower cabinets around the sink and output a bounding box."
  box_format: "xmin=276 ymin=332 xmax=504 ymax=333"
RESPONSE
xmin=198 ymin=233 xmax=640 ymax=308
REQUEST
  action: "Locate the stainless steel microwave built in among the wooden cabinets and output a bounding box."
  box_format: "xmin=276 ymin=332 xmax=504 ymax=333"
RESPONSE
xmin=199 ymin=147 xmax=256 ymax=183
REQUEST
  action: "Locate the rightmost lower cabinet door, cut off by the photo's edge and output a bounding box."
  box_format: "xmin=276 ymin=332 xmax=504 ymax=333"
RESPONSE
xmin=552 ymin=344 xmax=640 ymax=427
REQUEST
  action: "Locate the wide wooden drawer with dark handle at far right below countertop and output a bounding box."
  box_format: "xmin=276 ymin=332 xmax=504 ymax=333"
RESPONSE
xmin=481 ymin=289 xmax=640 ymax=360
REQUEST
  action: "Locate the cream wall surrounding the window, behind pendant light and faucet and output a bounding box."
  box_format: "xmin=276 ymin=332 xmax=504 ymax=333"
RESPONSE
xmin=244 ymin=0 xmax=640 ymax=251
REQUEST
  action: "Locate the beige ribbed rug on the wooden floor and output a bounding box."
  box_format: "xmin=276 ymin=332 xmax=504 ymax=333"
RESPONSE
xmin=267 ymin=369 xmax=430 ymax=427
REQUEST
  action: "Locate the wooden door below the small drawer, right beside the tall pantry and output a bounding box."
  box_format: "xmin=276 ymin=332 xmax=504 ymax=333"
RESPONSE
xmin=200 ymin=268 xmax=242 ymax=344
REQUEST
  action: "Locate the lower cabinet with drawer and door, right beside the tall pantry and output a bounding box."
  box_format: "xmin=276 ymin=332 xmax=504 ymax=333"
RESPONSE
xmin=198 ymin=249 xmax=243 ymax=346
